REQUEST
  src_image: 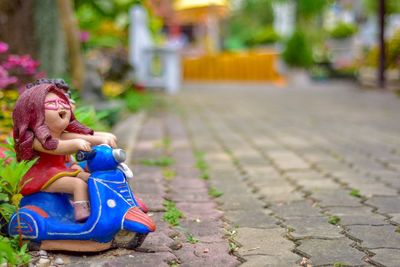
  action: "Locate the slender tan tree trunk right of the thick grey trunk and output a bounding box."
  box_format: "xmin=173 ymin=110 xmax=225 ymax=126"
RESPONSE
xmin=57 ymin=0 xmax=85 ymax=90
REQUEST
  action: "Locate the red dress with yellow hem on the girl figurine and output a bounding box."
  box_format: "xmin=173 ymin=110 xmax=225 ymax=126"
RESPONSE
xmin=21 ymin=152 xmax=81 ymax=196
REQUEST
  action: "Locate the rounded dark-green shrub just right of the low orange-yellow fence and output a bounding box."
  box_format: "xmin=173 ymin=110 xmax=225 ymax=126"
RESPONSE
xmin=282 ymin=30 xmax=312 ymax=68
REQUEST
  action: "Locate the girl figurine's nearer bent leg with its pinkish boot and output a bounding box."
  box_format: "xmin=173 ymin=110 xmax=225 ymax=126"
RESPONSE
xmin=43 ymin=176 xmax=90 ymax=222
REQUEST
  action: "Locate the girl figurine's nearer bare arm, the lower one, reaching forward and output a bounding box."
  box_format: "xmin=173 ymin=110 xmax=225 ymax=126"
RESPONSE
xmin=33 ymin=138 xmax=91 ymax=155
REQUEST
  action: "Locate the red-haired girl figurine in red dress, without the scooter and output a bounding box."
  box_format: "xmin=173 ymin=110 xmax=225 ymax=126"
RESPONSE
xmin=13 ymin=83 xmax=115 ymax=222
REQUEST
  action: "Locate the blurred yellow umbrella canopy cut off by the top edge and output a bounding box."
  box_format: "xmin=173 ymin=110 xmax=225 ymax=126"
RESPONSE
xmin=174 ymin=0 xmax=229 ymax=24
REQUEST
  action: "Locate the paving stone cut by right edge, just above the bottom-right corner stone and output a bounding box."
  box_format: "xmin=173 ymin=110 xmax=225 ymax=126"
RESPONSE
xmin=348 ymin=225 xmax=400 ymax=249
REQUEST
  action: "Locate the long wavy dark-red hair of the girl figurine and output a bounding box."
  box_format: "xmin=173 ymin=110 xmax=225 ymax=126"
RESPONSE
xmin=13 ymin=84 xmax=93 ymax=161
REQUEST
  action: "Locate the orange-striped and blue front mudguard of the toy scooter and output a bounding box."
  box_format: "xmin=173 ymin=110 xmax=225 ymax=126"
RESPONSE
xmin=122 ymin=207 xmax=156 ymax=234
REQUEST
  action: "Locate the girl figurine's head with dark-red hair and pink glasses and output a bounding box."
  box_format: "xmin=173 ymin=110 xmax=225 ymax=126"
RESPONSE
xmin=13 ymin=83 xmax=93 ymax=160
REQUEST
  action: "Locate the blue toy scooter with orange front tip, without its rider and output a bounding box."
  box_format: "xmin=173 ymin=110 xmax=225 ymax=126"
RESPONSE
xmin=8 ymin=145 xmax=156 ymax=251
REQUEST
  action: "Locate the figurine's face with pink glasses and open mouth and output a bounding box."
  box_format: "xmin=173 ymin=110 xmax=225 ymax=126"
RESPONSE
xmin=44 ymin=93 xmax=71 ymax=134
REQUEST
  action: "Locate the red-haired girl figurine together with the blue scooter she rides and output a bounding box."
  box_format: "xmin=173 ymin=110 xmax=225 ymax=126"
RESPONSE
xmin=8 ymin=80 xmax=156 ymax=251
